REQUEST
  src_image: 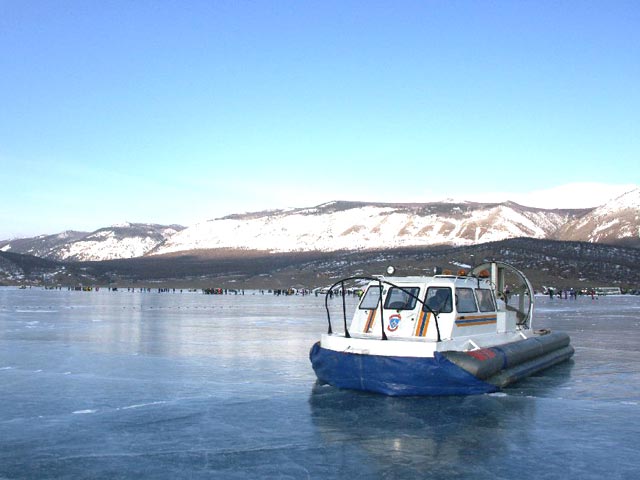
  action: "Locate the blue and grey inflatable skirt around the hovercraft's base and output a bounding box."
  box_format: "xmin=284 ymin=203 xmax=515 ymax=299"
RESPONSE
xmin=309 ymin=332 xmax=574 ymax=396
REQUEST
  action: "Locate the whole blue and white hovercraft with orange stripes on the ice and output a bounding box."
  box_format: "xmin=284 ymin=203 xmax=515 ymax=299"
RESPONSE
xmin=310 ymin=262 xmax=574 ymax=395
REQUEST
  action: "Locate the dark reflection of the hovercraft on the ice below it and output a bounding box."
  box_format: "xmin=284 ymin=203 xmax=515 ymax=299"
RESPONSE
xmin=310 ymin=387 xmax=535 ymax=478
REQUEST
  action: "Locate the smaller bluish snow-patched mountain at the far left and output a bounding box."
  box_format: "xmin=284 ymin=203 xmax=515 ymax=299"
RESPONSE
xmin=0 ymin=223 xmax=184 ymax=261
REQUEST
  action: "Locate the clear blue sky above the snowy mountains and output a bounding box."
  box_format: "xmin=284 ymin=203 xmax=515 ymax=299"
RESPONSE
xmin=0 ymin=0 xmax=640 ymax=239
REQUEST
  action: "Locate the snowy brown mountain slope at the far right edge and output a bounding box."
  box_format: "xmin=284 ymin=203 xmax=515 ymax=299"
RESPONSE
xmin=557 ymin=188 xmax=640 ymax=246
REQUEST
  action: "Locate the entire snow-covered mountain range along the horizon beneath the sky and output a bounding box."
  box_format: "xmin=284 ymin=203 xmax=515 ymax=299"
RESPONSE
xmin=0 ymin=188 xmax=640 ymax=262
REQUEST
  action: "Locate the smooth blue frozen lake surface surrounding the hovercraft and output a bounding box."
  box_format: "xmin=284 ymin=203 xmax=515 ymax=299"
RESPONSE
xmin=0 ymin=288 xmax=640 ymax=480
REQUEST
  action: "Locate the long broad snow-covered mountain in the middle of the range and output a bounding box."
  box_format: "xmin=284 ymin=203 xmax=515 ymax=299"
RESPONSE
xmin=153 ymin=202 xmax=589 ymax=254
